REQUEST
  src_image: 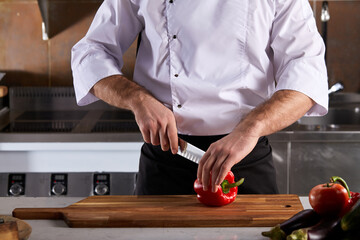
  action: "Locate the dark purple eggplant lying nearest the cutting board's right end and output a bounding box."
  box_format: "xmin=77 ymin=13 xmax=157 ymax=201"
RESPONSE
xmin=261 ymin=209 xmax=321 ymax=240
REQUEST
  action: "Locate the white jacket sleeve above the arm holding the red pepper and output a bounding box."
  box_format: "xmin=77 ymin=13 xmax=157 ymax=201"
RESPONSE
xmin=270 ymin=0 xmax=328 ymax=116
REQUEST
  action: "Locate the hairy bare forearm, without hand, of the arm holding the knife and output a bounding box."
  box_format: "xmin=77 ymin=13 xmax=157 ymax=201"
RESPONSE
xmin=90 ymin=75 xmax=153 ymax=112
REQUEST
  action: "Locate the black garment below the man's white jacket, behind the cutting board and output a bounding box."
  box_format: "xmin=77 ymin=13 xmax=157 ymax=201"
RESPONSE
xmin=135 ymin=135 xmax=278 ymax=195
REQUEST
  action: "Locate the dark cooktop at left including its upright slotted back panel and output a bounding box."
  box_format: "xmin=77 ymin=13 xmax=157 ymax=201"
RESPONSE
xmin=0 ymin=87 xmax=140 ymax=133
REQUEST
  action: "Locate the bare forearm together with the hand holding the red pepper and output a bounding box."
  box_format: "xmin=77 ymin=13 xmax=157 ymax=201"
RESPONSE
xmin=197 ymin=90 xmax=314 ymax=192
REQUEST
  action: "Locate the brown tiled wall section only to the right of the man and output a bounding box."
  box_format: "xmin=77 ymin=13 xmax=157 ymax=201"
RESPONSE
xmin=310 ymin=0 xmax=360 ymax=93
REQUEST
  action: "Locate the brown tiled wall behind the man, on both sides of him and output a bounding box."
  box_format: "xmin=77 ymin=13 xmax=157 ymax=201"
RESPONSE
xmin=0 ymin=0 xmax=360 ymax=92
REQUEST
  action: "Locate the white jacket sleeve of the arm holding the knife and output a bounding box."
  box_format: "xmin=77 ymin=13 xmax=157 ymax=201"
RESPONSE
xmin=71 ymin=0 xmax=143 ymax=105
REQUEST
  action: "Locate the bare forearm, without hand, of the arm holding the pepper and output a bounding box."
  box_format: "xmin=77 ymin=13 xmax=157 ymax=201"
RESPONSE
xmin=235 ymin=90 xmax=314 ymax=137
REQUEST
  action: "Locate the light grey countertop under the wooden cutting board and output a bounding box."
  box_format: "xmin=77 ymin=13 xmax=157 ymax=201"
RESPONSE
xmin=0 ymin=197 xmax=310 ymax=240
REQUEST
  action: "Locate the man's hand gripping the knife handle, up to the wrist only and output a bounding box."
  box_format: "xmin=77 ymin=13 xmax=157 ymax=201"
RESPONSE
xmin=132 ymin=96 xmax=178 ymax=154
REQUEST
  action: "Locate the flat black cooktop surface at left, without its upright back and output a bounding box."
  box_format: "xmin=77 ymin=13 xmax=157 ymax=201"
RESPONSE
xmin=1 ymin=111 xmax=140 ymax=133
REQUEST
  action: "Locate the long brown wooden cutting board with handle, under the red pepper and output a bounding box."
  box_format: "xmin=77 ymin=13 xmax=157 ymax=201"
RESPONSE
xmin=13 ymin=194 xmax=303 ymax=228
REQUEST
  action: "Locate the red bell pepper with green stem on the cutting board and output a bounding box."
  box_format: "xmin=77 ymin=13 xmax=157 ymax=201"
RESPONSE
xmin=194 ymin=171 xmax=244 ymax=206
